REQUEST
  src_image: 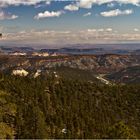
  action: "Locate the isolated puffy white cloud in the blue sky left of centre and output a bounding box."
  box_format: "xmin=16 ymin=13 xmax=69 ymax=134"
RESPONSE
xmin=34 ymin=11 xmax=64 ymax=19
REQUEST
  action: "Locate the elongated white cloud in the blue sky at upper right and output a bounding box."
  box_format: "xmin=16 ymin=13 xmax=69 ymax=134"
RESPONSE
xmin=101 ymin=9 xmax=133 ymax=17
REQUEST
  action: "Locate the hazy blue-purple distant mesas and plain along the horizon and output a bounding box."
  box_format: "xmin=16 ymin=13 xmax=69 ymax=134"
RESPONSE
xmin=0 ymin=44 xmax=140 ymax=55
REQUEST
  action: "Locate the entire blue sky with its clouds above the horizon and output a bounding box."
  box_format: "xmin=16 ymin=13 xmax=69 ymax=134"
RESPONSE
xmin=0 ymin=0 xmax=140 ymax=45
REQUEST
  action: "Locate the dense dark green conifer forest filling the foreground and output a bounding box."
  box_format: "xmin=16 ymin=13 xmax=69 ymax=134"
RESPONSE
xmin=0 ymin=74 xmax=140 ymax=139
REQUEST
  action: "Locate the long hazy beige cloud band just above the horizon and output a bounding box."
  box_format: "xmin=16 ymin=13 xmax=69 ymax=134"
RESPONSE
xmin=1 ymin=28 xmax=140 ymax=45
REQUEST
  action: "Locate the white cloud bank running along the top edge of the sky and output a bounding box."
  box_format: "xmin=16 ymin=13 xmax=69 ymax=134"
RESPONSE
xmin=0 ymin=0 xmax=140 ymax=9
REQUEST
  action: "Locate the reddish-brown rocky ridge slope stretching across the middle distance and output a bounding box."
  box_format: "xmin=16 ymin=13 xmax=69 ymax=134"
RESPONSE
xmin=0 ymin=54 xmax=140 ymax=73
